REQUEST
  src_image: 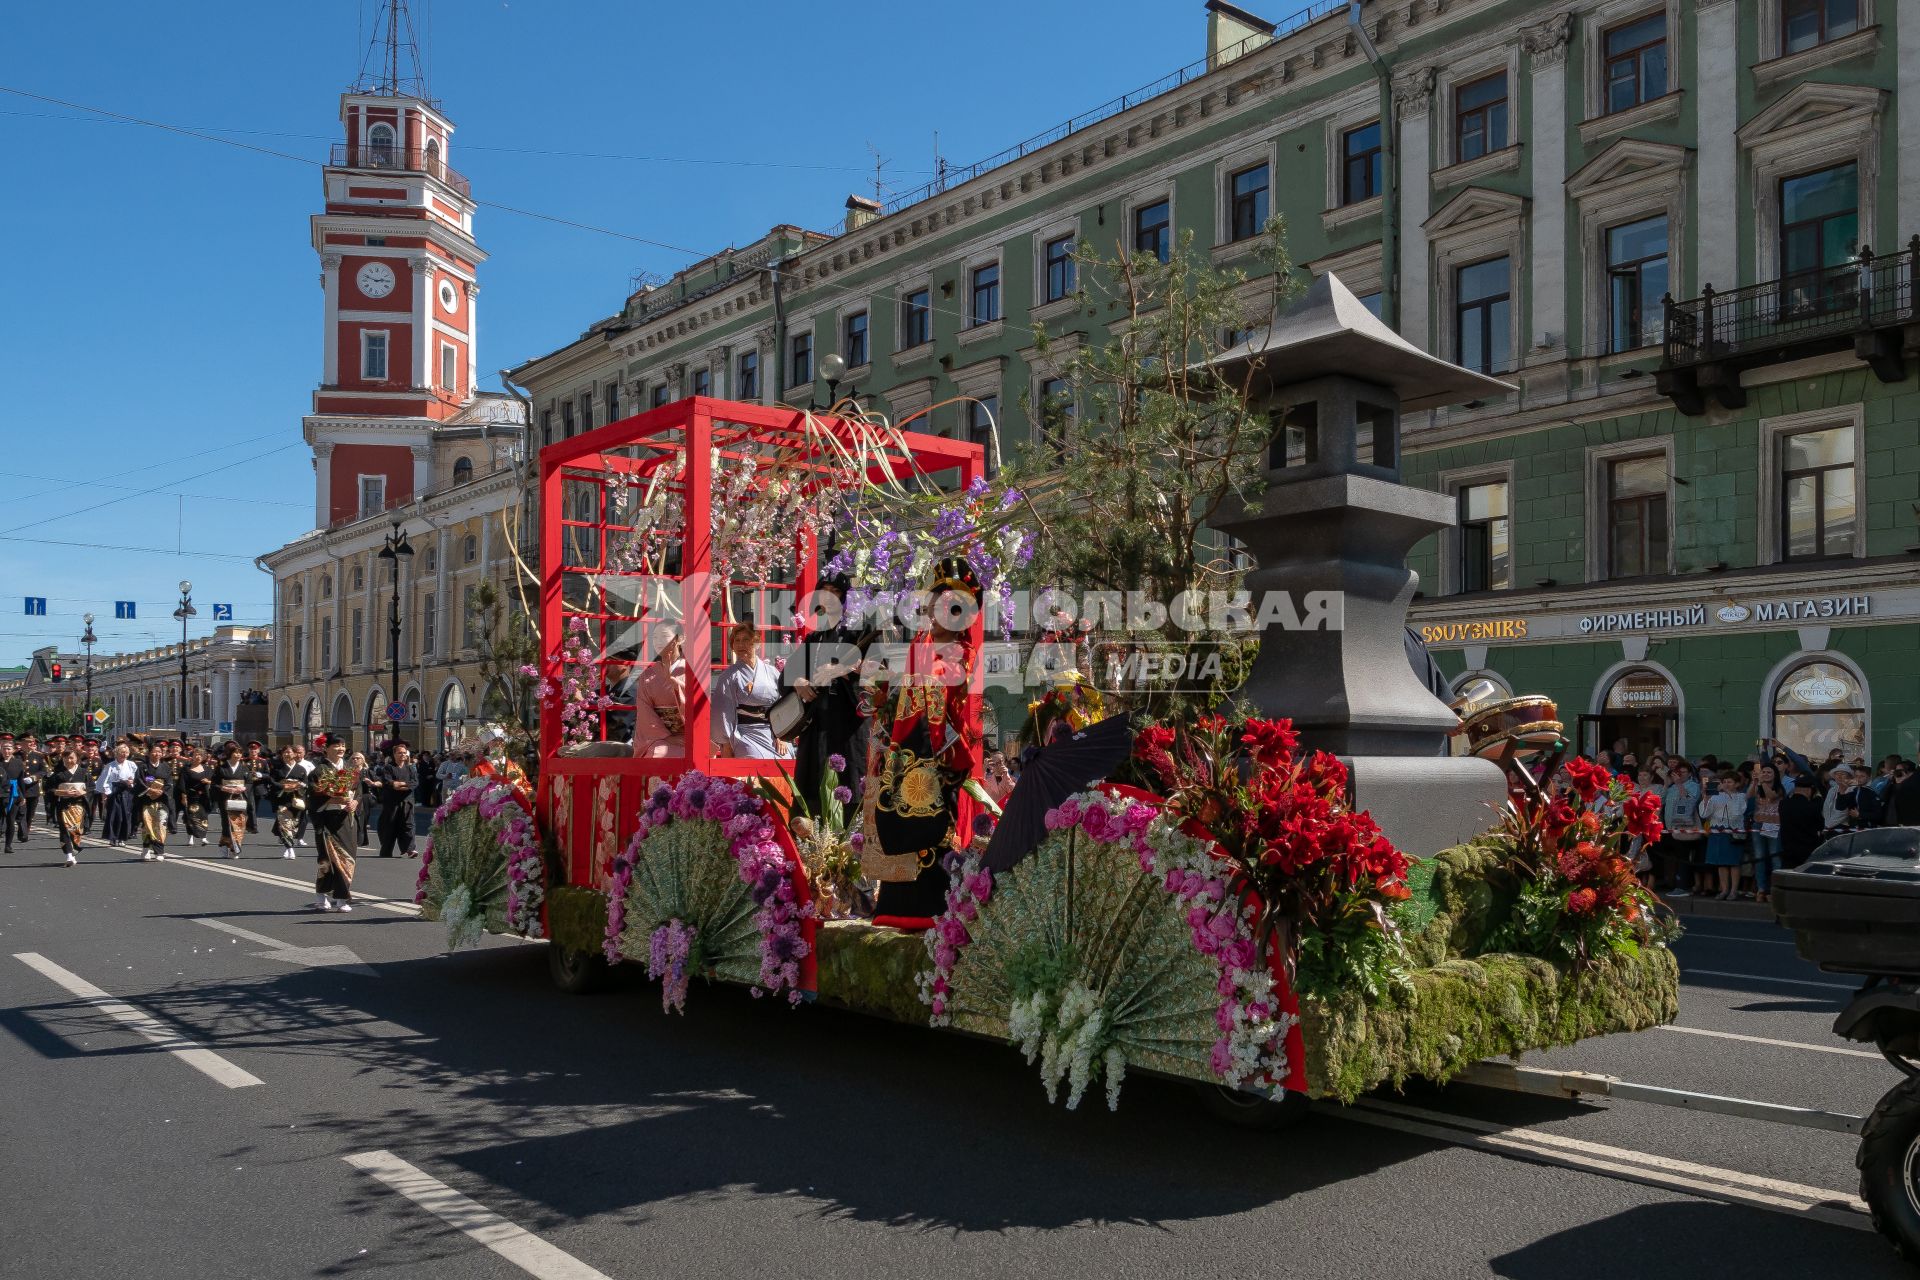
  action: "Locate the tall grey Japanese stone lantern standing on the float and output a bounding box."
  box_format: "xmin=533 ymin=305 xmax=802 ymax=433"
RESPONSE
xmin=1213 ymin=274 xmax=1513 ymax=858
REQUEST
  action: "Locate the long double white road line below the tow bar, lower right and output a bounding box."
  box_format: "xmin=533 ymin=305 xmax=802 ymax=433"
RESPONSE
xmin=1329 ymin=1098 xmax=1874 ymax=1232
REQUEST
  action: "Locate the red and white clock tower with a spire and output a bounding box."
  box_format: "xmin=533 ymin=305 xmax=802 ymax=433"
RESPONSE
xmin=305 ymin=0 xmax=486 ymax=528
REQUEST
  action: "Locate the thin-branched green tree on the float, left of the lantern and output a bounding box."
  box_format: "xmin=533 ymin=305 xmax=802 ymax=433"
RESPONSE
xmin=1014 ymin=219 xmax=1292 ymax=714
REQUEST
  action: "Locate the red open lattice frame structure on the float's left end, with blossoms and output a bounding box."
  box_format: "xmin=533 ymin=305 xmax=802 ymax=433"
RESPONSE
xmin=540 ymin=395 xmax=985 ymax=889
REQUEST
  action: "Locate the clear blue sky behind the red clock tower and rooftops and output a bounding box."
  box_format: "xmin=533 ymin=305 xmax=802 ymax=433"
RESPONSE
xmin=0 ymin=0 xmax=1221 ymax=666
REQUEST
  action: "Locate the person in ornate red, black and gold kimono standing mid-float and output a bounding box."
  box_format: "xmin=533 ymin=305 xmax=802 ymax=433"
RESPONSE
xmin=862 ymin=558 xmax=995 ymax=917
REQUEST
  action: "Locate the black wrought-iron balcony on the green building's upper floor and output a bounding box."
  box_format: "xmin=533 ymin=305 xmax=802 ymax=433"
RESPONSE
xmin=1659 ymin=234 xmax=1920 ymax=413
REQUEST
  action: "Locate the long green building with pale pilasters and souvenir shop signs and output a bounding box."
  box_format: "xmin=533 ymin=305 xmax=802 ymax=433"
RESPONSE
xmin=513 ymin=0 xmax=1920 ymax=756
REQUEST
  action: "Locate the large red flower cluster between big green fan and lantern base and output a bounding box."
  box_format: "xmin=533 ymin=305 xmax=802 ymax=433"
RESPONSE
xmin=1133 ymin=716 xmax=1409 ymax=994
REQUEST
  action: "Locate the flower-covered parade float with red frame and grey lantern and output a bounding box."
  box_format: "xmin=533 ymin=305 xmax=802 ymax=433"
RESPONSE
xmin=420 ymin=280 xmax=1678 ymax=1123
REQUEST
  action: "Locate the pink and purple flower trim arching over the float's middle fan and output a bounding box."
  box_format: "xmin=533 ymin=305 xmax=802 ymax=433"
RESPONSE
xmin=605 ymin=770 xmax=812 ymax=1004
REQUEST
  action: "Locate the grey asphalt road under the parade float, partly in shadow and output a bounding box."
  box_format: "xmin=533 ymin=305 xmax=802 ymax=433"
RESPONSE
xmin=0 ymin=833 xmax=1910 ymax=1280
